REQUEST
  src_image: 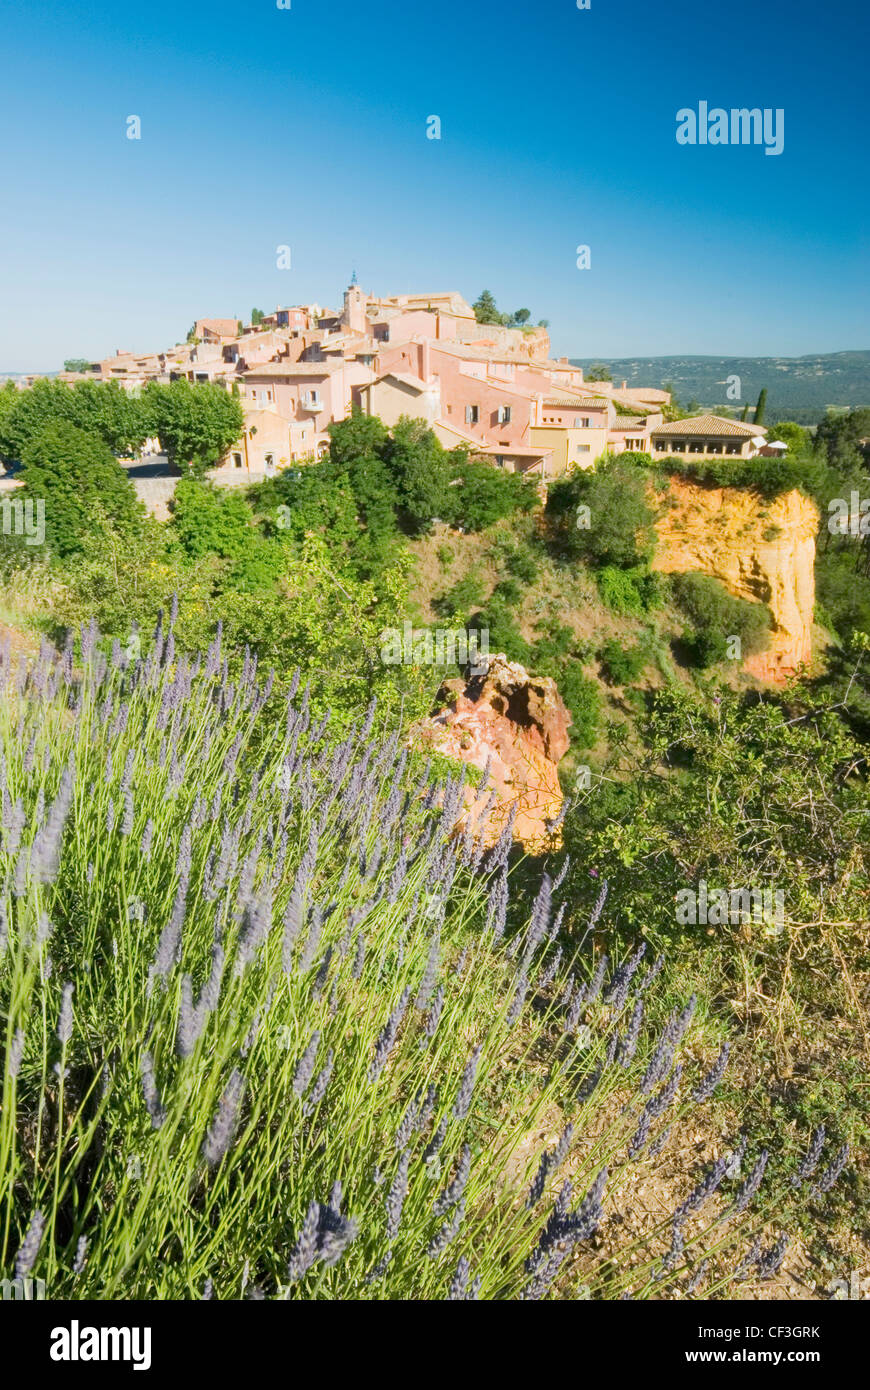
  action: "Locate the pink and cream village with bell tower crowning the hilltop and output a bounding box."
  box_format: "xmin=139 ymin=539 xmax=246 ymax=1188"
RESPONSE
xmin=60 ymin=282 xmax=777 ymax=482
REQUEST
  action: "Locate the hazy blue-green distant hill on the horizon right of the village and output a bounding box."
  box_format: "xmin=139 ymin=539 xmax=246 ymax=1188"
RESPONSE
xmin=571 ymin=352 xmax=870 ymax=424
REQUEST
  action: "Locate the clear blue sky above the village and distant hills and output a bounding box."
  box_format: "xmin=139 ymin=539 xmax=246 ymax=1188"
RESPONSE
xmin=0 ymin=0 xmax=870 ymax=371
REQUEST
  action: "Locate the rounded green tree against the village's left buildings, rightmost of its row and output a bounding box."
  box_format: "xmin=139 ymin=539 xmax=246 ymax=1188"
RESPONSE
xmin=142 ymin=379 xmax=245 ymax=477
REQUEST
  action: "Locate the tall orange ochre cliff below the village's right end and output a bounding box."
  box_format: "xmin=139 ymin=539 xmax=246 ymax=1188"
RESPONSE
xmin=653 ymin=477 xmax=819 ymax=681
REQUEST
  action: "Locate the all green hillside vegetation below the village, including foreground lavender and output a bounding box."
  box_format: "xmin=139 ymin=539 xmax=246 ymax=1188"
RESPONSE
xmin=0 ymin=388 xmax=870 ymax=1298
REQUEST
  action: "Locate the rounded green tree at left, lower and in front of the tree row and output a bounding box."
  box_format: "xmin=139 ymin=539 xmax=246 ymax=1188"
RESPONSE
xmin=21 ymin=420 xmax=145 ymax=556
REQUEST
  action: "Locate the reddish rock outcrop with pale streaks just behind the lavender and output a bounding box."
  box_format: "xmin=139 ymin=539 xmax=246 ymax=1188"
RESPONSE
xmin=413 ymin=653 xmax=571 ymax=851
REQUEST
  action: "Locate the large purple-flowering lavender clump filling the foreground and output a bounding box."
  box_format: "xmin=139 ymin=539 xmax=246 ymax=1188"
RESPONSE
xmin=0 ymin=630 xmax=828 ymax=1300
